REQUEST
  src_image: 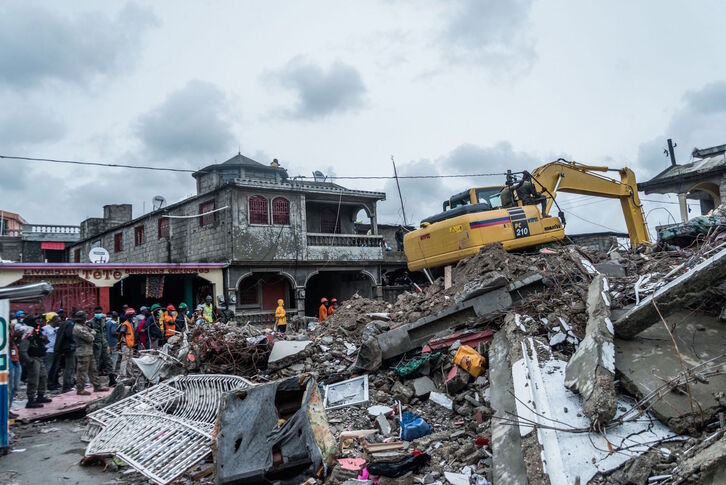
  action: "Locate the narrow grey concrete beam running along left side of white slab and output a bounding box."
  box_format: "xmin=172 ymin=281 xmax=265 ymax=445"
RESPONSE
xmin=489 ymin=332 xmax=528 ymax=485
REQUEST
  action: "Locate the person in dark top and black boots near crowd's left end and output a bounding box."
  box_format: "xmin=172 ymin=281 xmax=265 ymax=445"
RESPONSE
xmin=20 ymin=317 xmax=52 ymax=408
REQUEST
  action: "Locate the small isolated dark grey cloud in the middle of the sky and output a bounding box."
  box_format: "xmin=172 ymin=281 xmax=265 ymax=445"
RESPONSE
xmin=266 ymin=56 xmax=366 ymax=119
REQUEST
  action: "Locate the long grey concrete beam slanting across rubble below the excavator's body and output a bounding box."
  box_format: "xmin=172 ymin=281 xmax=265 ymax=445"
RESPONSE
xmin=356 ymin=287 xmax=512 ymax=371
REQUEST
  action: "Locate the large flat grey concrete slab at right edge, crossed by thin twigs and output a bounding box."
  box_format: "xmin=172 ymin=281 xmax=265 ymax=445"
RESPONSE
xmin=615 ymin=310 xmax=726 ymax=433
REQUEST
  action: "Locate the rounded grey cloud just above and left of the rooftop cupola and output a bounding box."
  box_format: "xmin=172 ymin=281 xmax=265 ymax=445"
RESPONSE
xmin=136 ymin=81 xmax=234 ymax=164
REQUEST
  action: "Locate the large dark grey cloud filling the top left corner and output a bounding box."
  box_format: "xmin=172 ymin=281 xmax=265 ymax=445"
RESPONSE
xmin=0 ymin=2 xmax=157 ymax=88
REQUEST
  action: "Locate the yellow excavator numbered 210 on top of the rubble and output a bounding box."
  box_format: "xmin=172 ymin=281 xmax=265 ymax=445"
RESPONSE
xmin=403 ymin=159 xmax=650 ymax=271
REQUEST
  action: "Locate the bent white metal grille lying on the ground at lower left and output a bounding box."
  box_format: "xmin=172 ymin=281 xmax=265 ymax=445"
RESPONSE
xmin=85 ymin=374 xmax=253 ymax=485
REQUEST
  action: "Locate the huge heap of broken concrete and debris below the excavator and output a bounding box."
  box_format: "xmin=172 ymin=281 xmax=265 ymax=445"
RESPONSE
xmin=78 ymin=240 xmax=726 ymax=485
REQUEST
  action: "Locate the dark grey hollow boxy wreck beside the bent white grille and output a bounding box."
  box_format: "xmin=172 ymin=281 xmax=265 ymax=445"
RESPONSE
xmin=215 ymin=376 xmax=336 ymax=484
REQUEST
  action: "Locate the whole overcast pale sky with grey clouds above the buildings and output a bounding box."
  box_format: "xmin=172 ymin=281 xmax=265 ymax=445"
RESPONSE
xmin=0 ymin=0 xmax=726 ymax=238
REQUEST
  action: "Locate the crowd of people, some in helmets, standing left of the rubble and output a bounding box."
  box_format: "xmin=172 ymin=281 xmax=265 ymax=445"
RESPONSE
xmin=9 ymin=296 xmax=220 ymax=414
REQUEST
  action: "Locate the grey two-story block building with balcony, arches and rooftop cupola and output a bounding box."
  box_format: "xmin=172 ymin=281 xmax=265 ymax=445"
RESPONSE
xmin=64 ymin=154 xmax=405 ymax=322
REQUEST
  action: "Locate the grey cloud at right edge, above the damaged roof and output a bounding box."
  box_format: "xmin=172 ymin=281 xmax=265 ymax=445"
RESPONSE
xmin=637 ymin=81 xmax=726 ymax=176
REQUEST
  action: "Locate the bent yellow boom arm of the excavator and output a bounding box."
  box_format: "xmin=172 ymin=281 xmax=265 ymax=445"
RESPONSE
xmin=531 ymin=159 xmax=650 ymax=248
